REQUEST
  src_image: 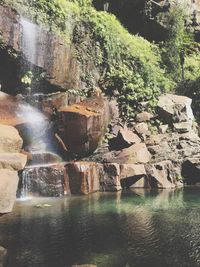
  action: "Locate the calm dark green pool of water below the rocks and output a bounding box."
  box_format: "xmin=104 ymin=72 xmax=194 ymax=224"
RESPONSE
xmin=0 ymin=188 xmax=200 ymax=267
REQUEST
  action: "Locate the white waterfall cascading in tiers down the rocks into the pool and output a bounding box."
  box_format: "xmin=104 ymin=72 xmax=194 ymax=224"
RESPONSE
xmin=17 ymin=17 xmax=63 ymax=199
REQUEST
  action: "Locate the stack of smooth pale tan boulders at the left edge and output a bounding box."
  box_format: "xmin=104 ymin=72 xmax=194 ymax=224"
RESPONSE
xmin=0 ymin=125 xmax=27 ymax=213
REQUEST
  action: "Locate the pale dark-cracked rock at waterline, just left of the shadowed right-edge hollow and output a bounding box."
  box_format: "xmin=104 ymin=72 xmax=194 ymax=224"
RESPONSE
xmin=145 ymin=160 xmax=177 ymax=188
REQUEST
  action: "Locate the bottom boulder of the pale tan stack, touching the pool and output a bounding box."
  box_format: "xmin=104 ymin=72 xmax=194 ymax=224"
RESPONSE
xmin=0 ymin=169 xmax=19 ymax=213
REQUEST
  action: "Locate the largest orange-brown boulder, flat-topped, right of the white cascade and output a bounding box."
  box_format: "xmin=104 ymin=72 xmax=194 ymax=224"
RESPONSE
xmin=59 ymin=96 xmax=109 ymax=156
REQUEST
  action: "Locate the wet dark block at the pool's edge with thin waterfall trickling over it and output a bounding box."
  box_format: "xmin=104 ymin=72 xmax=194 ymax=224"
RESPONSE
xmin=19 ymin=163 xmax=70 ymax=197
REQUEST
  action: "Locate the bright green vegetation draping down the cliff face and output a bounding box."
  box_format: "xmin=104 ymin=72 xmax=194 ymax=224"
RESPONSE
xmin=0 ymin=0 xmax=200 ymax=120
